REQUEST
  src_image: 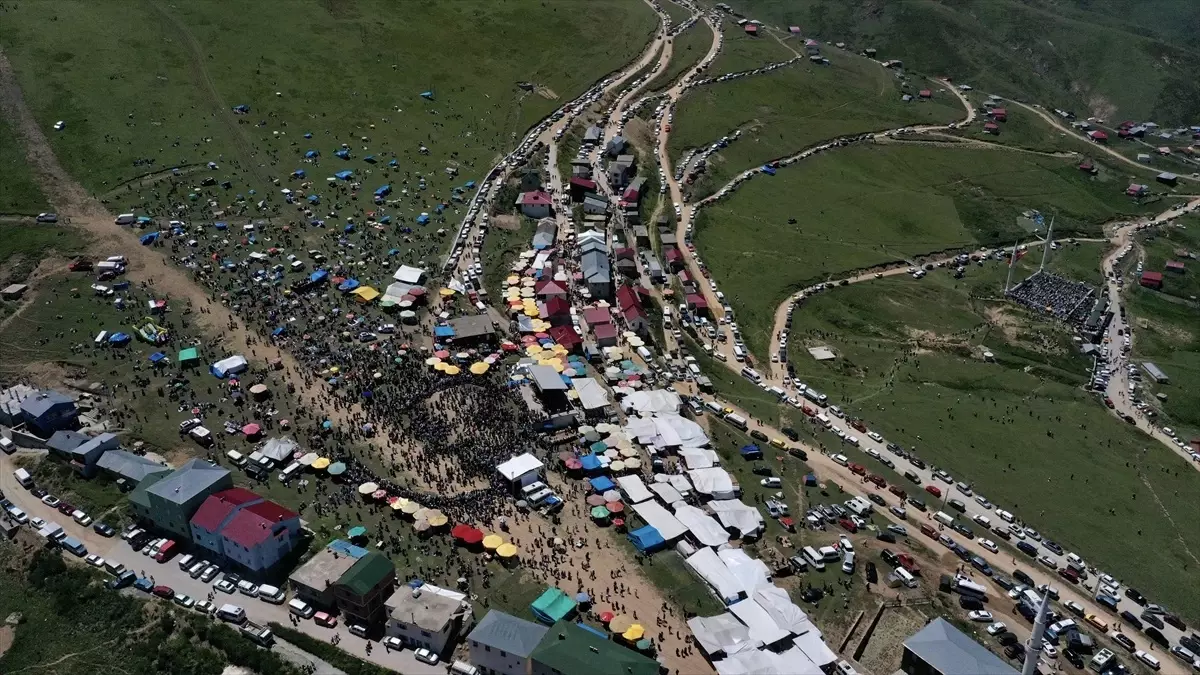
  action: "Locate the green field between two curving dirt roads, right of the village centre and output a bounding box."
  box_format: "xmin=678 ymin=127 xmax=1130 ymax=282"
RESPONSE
xmin=696 ymin=145 xmax=1146 ymax=358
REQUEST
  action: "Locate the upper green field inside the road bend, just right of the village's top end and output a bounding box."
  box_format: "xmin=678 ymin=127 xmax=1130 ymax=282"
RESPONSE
xmin=668 ymin=53 xmax=962 ymax=196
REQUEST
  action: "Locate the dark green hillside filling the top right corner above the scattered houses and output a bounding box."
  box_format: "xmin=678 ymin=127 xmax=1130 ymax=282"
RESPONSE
xmin=720 ymin=0 xmax=1200 ymax=125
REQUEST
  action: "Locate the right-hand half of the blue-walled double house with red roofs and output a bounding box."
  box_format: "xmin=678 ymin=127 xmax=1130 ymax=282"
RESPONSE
xmin=221 ymin=500 xmax=300 ymax=572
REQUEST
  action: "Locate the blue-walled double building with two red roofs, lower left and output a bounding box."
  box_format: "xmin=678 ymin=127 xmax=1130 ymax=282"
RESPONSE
xmin=191 ymin=488 xmax=300 ymax=573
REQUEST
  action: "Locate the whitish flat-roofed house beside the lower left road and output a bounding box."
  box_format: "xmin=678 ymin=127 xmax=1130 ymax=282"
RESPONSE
xmin=385 ymin=583 xmax=472 ymax=655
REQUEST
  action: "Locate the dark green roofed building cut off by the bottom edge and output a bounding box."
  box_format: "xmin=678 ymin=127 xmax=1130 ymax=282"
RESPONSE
xmin=529 ymin=621 xmax=659 ymax=675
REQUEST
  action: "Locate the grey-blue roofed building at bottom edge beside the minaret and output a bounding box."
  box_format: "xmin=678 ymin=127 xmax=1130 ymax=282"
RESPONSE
xmin=900 ymin=619 xmax=1018 ymax=675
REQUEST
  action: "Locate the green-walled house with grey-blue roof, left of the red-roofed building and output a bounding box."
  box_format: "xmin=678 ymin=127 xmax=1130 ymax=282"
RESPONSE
xmin=131 ymin=459 xmax=233 ymax=539
